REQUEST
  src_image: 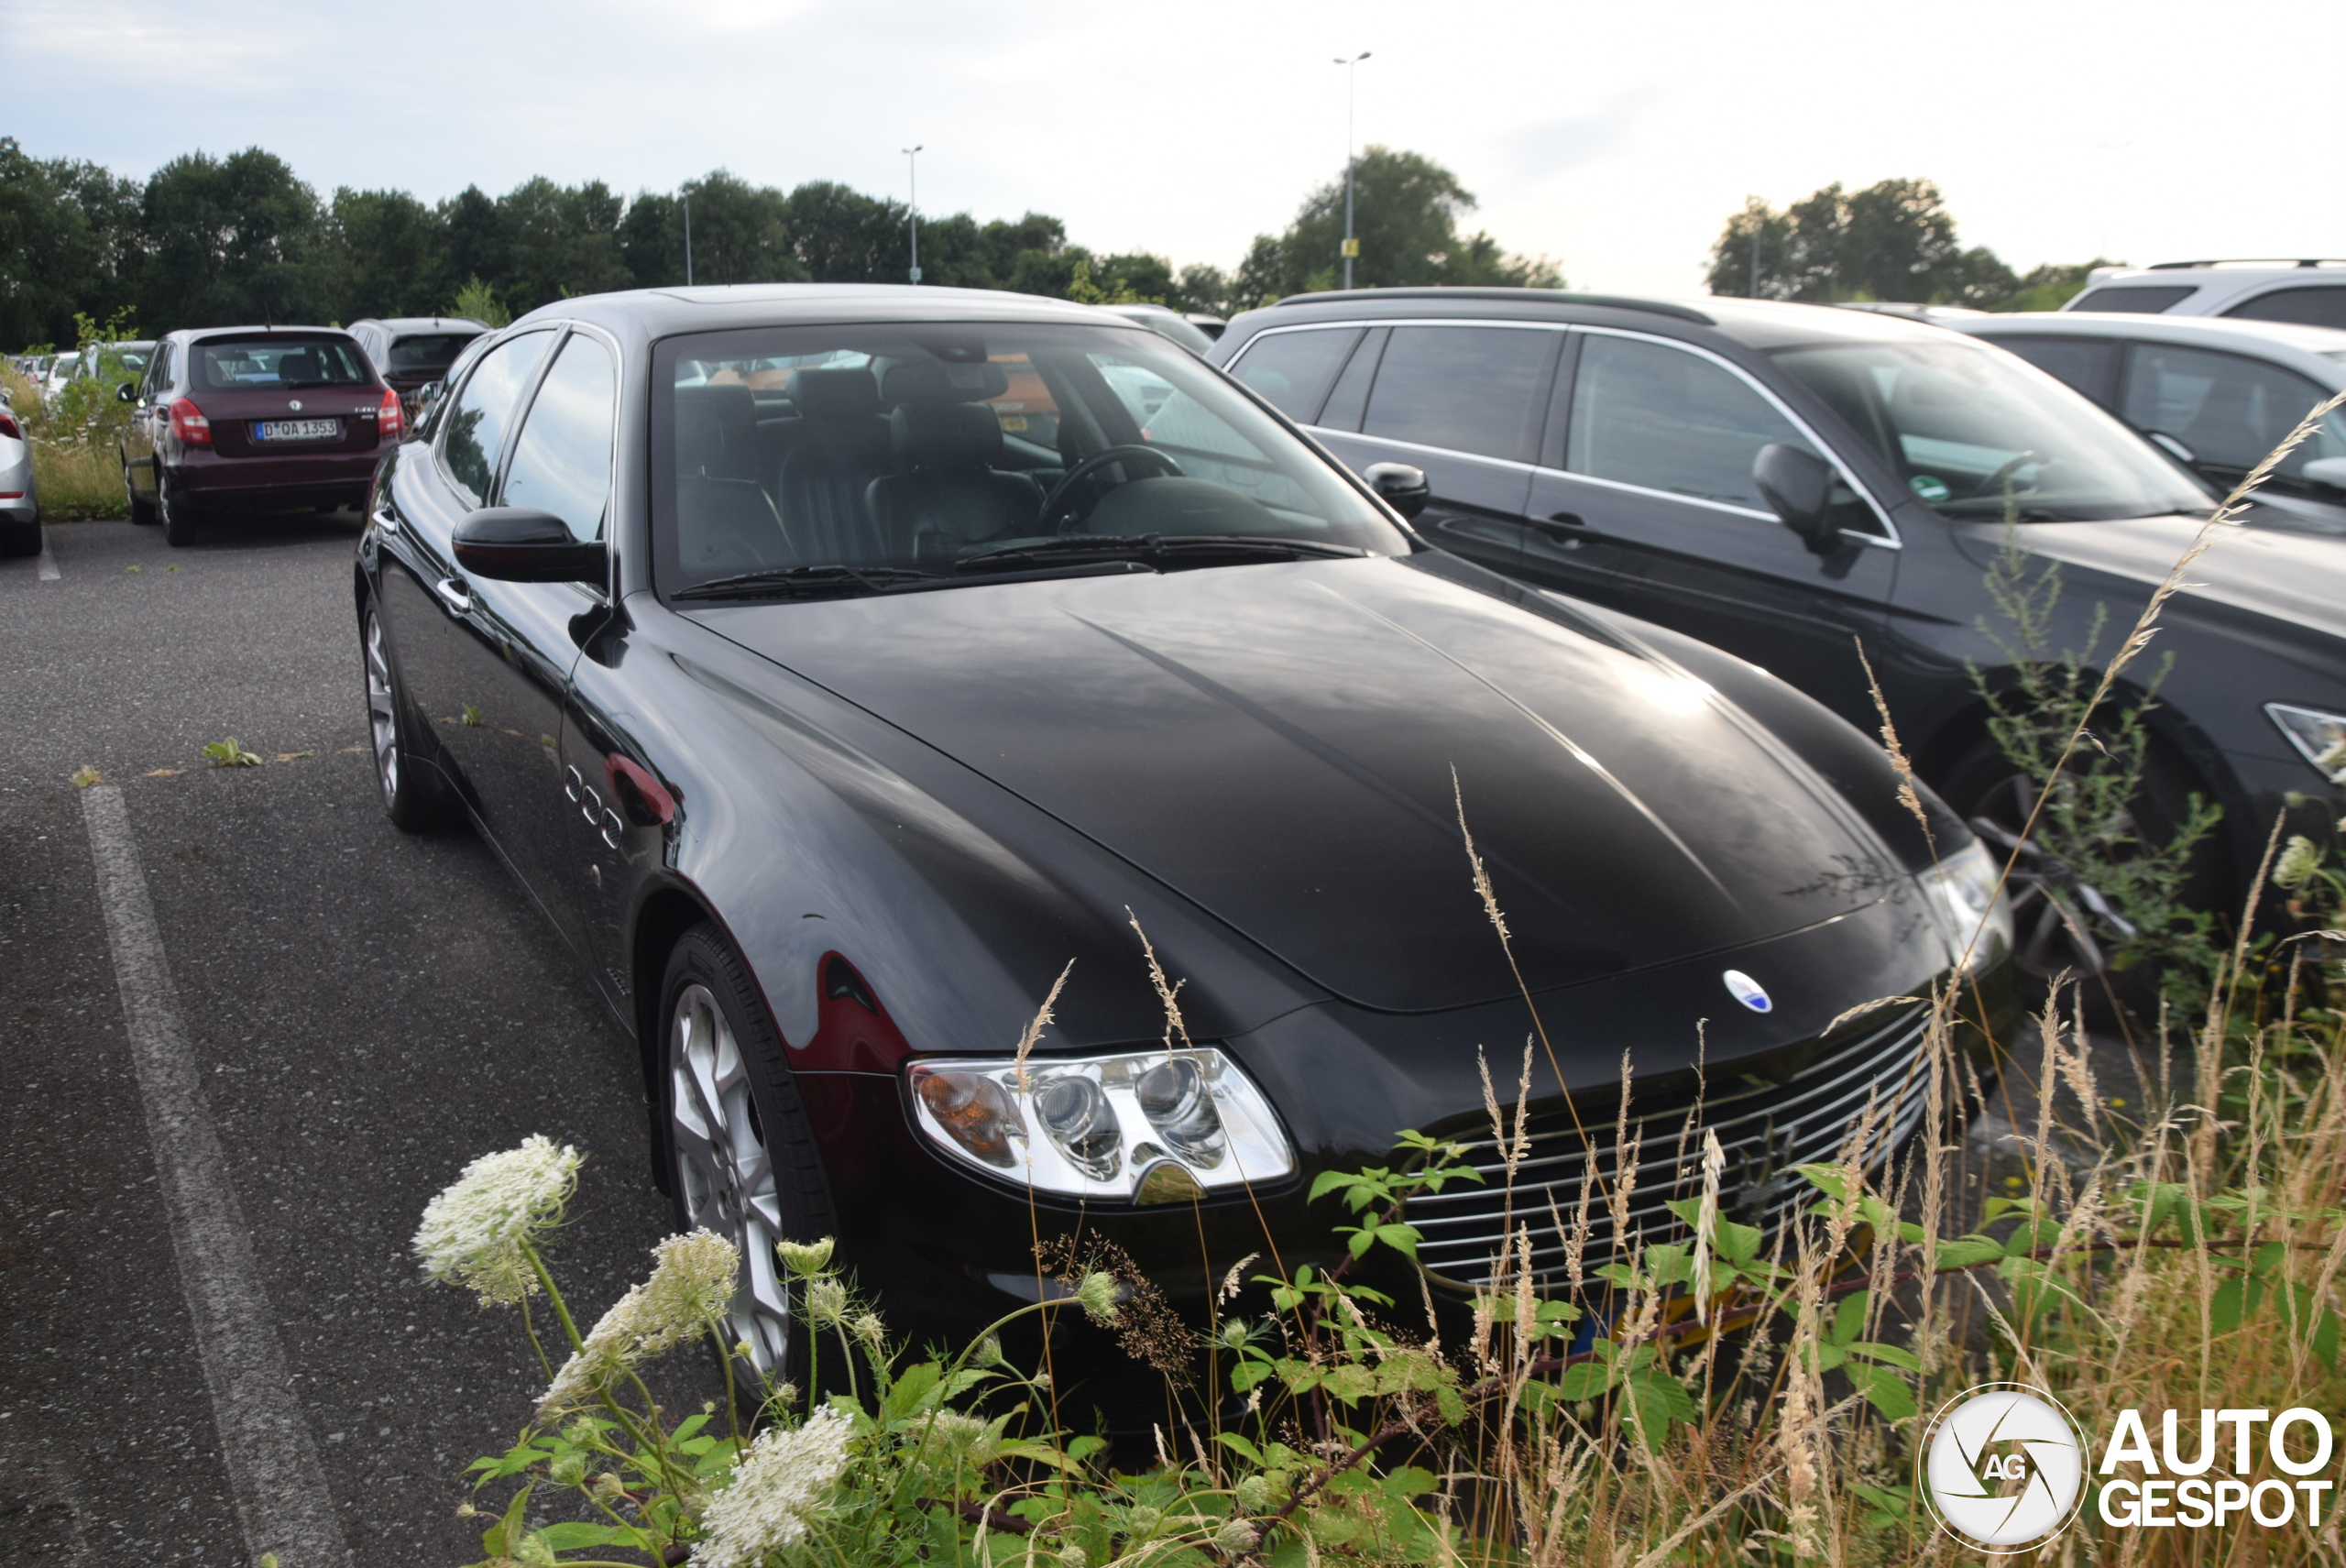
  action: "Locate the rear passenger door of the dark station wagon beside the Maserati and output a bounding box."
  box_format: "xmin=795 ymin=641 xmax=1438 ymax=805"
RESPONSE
xmin=1316 ymin=322 xmax=1567 ymax=573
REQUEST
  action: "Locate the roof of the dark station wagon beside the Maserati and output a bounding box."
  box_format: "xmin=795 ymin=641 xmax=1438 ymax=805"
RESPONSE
xmin=1232 ymin=289 xmax=1947 ymax=352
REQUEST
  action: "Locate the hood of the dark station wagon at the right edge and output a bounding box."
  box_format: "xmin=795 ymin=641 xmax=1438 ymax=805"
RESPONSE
xmin=1968 ymin=517 xmax=2346 ymax=636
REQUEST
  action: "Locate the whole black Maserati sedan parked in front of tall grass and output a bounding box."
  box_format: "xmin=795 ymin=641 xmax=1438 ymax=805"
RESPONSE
xmin=355 ymin=286 xmax=2008 ymax=1356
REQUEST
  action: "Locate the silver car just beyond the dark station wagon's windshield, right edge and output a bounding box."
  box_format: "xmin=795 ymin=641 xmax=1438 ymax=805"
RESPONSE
xmin=1945 ymin=313 xmax=2346 ymax=535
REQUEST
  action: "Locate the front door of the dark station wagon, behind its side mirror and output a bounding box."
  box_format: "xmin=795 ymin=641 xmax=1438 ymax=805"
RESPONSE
xmin=1520 ymin=326 xmax=1898 ymax=723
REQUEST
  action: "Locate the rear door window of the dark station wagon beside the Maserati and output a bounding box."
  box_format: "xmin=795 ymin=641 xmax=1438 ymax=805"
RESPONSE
xmin=1361 ymin=326 xmax=1565 ymax=463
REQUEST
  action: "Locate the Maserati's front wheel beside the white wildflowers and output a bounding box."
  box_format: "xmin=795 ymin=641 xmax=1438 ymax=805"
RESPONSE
xmin=659 ymin=923 xmax=833 ymax=1383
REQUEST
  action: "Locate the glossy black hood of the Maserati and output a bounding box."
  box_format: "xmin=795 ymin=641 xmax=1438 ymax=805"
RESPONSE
xmin=692 ymin=559 xmax=1905 ymax=1012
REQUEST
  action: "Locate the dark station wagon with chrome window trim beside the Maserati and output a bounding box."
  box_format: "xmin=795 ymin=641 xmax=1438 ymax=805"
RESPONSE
xmin=1213 ymin=289 xmax=2346 ymax=971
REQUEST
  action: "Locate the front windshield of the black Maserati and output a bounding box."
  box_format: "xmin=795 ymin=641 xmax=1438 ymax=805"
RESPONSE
xmin=652 ymin=322 xmax=1410 ymax=594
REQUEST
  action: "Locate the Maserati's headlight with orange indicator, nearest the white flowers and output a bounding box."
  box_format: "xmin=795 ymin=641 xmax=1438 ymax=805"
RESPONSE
xmin=910 ymin=1047 xmax=1295 ymax=1204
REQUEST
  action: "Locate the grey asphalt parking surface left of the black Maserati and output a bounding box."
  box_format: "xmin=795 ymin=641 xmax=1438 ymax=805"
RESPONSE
xmin=0 ymin=514 xmax=707 ymax=1568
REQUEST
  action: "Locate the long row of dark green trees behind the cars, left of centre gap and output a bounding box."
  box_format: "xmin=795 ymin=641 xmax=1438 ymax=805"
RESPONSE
xmin=0 ymin=137 xmax=1562 ymax=347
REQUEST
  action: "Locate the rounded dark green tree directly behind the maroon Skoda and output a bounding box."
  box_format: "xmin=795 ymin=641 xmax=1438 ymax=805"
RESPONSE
xmin=138 ymin=148 xmax=334 ymax=331
